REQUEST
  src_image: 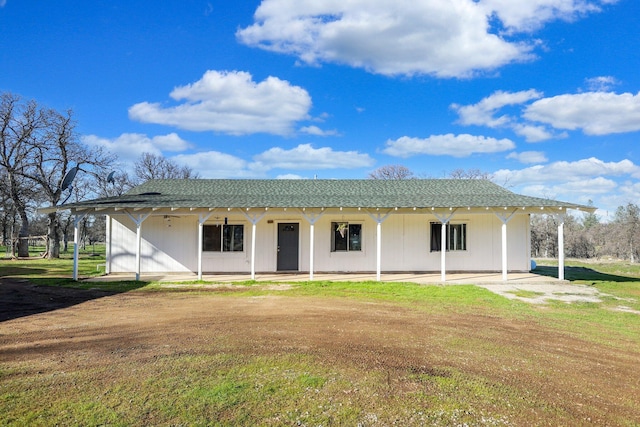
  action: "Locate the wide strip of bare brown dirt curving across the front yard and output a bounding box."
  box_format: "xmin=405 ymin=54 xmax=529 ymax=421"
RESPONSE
xmin=0 ymin=280 xmax=640 ymax=425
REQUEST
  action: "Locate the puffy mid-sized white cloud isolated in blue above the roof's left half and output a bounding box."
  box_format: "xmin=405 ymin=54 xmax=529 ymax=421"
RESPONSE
xmin=129 ymin=70 xmax=311 ymax=135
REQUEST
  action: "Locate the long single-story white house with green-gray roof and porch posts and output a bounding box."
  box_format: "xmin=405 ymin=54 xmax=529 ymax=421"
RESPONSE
xmin=43 ymin=179 xmax=594 ymax=281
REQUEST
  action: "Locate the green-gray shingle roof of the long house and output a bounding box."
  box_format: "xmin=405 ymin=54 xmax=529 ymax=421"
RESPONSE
xmin=48 ymin=179 xmax=594 ymax=211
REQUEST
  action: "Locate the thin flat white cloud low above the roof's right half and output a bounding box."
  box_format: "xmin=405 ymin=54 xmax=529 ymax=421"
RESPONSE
xmin=383 ymin=134 xmax=515 ymax=158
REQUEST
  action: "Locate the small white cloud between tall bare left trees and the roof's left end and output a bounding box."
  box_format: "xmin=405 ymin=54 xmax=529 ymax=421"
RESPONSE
xmin=82 ymin=133 xmax=190 ymax=163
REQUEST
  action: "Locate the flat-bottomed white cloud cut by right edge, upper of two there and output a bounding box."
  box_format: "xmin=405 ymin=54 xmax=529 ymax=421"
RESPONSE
xmin=524 ymin=92 xmax=640 ymax=135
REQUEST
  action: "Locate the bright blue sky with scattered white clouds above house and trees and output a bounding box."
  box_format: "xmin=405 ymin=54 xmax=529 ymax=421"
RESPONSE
xmin=0 ymin=0 xmax=640 ymax=220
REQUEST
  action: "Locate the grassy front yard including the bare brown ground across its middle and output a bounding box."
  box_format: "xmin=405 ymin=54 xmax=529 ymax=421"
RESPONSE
xmin=0 ymin=256 xmax=640 ymax=426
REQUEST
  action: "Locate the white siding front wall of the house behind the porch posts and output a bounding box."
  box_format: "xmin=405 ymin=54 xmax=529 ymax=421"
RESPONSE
xmin=111 ymin=211 xmax=530 ymax=273
